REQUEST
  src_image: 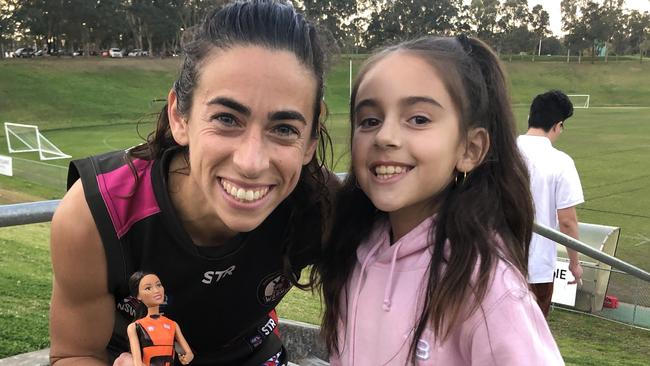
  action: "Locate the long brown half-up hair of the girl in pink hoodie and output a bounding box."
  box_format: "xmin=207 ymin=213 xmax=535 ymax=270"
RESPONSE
xmin=318 ymin=36 xmax=534 ymax=357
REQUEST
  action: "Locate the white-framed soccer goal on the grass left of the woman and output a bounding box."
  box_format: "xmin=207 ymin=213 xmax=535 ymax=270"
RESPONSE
xmin=5 ymin=122 xmax=70 ymax=160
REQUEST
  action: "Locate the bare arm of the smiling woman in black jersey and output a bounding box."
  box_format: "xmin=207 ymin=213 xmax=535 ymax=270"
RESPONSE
xmin=50 ymin=181 xmax=115 ymax=366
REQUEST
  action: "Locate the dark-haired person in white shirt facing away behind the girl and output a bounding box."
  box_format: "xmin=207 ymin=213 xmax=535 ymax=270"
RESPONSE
xmin=517 ymin=90 xmax=584 ymax=315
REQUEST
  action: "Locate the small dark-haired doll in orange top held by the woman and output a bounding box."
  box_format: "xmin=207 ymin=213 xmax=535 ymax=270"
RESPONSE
xmin=126 ymin=271 xmax=194 ymax=366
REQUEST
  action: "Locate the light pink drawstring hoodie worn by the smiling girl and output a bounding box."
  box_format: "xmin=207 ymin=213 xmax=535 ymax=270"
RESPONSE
xmin=330 ymin=218 xmax=564 ymax=366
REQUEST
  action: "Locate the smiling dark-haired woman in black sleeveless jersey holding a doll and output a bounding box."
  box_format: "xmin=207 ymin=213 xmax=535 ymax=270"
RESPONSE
xmin=50 ymin=0 xmax=334 ymax=366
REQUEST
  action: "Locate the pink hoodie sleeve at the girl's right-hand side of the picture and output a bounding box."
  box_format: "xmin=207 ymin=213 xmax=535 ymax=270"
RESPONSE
xmin=462 ymin=269 xmax=564 ymax=366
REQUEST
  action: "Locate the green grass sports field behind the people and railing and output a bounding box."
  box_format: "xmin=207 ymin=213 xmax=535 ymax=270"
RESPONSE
xmin=0 ymin=59 xmax=650 ymax=365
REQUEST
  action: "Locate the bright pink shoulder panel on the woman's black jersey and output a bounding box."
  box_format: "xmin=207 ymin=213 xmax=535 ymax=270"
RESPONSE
xmin=97 ymin=159 xmax=160 ymax=238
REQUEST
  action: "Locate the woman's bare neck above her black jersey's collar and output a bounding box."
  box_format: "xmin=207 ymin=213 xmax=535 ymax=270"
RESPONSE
xmin=167 ymin=154 xmax=237 ymax=246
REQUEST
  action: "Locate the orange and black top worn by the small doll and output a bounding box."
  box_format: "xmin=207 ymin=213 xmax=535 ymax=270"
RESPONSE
xmin=135 ymin=315 xmax=176 ymax=365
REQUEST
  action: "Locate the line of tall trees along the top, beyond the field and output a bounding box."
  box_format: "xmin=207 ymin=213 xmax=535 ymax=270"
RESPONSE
xmin=0 ymin=0 xmax=650 ymax=57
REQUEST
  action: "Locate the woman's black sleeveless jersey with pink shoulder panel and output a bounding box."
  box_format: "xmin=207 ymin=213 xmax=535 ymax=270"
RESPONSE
xmin=68 ymin=151 xmax=320 ymax=366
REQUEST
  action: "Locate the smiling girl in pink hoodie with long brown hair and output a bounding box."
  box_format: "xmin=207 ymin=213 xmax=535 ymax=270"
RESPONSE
xmin=321 ymin=36 xmax=563 ymax=366
